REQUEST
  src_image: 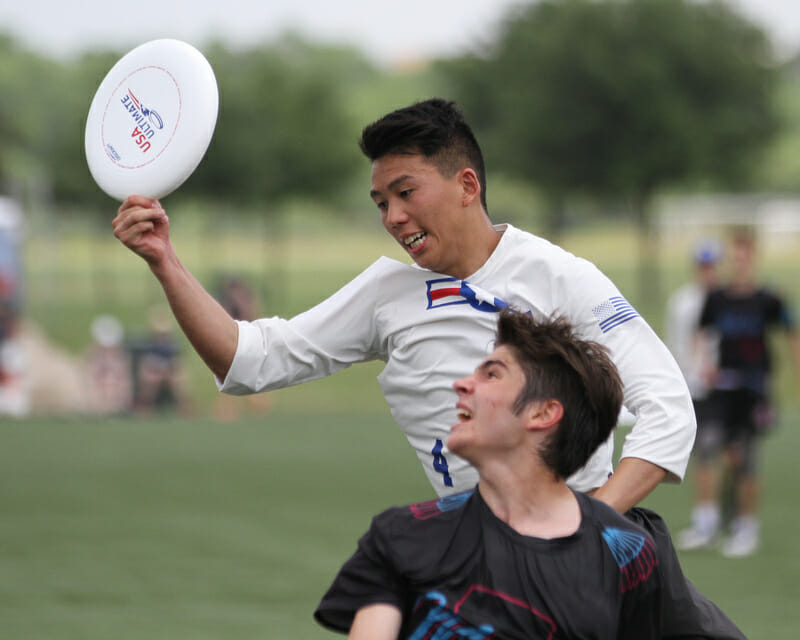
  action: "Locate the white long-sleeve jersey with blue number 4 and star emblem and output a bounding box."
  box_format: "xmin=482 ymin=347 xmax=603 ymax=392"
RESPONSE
xmin=218 ymin=225 xmax=695 ymax=495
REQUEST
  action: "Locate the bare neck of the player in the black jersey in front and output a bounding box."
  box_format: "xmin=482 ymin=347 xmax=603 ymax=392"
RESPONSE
xmin=478 ymin=461 xmax=581 ymax=539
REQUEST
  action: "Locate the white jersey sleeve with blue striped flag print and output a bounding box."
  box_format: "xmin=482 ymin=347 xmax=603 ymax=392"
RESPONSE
xmin=557 ymin=259 xmax=697 ymax=482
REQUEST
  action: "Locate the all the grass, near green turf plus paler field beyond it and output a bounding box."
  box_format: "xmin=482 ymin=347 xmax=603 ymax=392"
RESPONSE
xmin=6 ymin=210 xmax=800 ymax=640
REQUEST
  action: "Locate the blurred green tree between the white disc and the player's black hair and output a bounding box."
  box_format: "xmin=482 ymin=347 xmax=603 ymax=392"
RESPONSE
xmin=192 ymin=39 xmax=363 ymax=202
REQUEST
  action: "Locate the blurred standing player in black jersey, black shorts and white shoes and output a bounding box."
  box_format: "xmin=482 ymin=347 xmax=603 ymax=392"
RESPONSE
xmin=678 ymin=229 xmax=800 ymax=557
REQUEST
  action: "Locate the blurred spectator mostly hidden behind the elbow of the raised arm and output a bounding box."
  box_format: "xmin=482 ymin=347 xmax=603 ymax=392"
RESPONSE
xmin=214 ymin=276 xmax=272 ymax=422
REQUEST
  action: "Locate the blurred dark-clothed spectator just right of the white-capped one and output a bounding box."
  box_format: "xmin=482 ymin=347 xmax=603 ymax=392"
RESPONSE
xmin=130 ymin=308 xmax=188 ymax=415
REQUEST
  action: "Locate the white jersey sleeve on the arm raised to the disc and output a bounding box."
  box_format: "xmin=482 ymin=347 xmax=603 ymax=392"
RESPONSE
xmin=217 ymin=263 xmax=384 ymax=395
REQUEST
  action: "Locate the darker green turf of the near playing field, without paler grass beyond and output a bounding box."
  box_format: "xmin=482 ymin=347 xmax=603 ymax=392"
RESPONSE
xmin=0 ymin=402 xmax=800 ymax=640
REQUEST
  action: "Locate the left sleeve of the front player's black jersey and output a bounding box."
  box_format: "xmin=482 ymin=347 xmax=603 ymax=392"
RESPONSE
xmin=314 ymin=516 xmax=407 ymax=632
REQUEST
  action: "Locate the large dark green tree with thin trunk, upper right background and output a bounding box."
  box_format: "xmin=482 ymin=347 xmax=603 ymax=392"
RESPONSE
xmin=445 ymin=0 xmax=777 ymax=298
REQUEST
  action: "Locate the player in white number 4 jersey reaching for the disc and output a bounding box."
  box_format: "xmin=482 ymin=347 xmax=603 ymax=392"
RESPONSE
xmin=113 ymin=99 xmax=695 ymax=511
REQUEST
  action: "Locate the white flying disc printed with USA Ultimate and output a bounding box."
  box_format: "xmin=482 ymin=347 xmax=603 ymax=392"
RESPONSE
xmin=85 ymin=39 xmax=219 ymax=200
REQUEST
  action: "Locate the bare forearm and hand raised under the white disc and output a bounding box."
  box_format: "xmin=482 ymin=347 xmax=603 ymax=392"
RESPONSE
xmin=112 ymin=196 xmax=238 ymax=379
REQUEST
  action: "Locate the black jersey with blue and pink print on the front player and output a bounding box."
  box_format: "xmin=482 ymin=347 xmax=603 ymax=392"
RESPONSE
xmin=314 ymin=491 xmax=660 ymax=640
